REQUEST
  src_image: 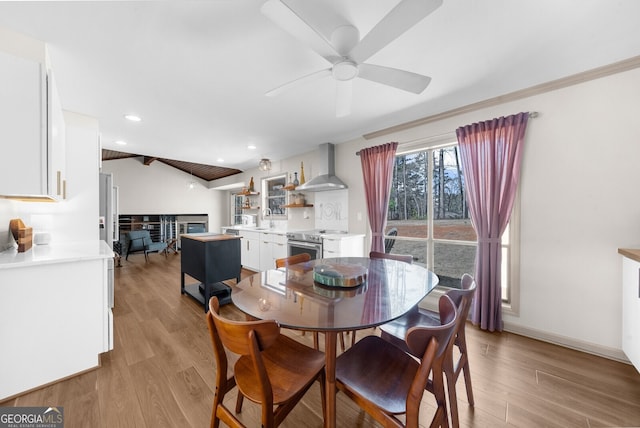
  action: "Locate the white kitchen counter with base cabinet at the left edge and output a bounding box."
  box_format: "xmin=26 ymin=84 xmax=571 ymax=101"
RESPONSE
xmin=0 ymin=240 xmax=113 ymax=401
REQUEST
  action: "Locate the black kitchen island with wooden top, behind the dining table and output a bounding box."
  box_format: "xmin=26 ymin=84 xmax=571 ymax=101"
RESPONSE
xmin=180 ymin=233 xmax=242 ymax=312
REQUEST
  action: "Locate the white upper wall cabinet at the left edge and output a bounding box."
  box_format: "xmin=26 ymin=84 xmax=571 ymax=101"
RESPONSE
xmin=0 ymin=51 xmax=65 ymax=201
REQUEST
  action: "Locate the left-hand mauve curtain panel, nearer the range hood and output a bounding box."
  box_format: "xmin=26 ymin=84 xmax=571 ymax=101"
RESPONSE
xmin=359 ymin=142 xmax=398 ymax=253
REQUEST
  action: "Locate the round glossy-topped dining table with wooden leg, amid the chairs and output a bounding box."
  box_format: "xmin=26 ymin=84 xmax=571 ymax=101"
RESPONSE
xmin=231 ymin=257 xmax=438 ymax=427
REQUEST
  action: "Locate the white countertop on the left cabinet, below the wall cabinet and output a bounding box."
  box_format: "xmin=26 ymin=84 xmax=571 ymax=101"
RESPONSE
xmin=0 ymin=240 xmax=113 ymax=269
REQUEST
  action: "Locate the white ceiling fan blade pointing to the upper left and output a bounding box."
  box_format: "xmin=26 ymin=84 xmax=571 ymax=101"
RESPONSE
xmin=260 ymin=0 xmax=342 ymax=64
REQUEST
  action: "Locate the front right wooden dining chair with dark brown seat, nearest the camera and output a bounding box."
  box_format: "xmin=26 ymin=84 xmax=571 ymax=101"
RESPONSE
xmin=336 ymin=296 xmax=457 ymax=428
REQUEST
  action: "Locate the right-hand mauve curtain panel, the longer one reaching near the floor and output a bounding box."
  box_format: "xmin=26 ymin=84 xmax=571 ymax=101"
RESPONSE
xmin=456 ymin=112 xmax=529 ymax=331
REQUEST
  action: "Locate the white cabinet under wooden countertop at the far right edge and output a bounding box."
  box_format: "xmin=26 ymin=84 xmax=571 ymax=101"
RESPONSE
xmin=622 ymin=257 xmax=640 ymax=370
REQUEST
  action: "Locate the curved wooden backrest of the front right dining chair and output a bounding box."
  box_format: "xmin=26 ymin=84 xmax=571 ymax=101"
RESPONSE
xmin=405 ymin=294 xmax=458 ymax=358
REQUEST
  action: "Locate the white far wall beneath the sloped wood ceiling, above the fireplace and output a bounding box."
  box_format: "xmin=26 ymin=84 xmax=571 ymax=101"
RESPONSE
xmin=102 ymin=157 xmax=229 ymax=232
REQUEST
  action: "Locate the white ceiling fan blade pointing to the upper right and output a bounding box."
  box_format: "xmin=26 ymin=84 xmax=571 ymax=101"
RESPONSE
xmin=349 ymin=0 xmax=442 ymax=63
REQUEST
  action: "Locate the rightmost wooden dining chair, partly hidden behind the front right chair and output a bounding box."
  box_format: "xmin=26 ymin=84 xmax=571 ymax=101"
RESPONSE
xmin=380 ymin=274 xmax=476 ymax=428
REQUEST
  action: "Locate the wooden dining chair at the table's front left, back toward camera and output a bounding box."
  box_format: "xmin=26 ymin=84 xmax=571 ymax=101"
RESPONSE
xmin=207 ymin=296 xmax=326 ymax=428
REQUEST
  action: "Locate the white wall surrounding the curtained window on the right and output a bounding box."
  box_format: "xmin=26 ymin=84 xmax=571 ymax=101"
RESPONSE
xmin=336 ymin=70 xmax=640 ymax=358
